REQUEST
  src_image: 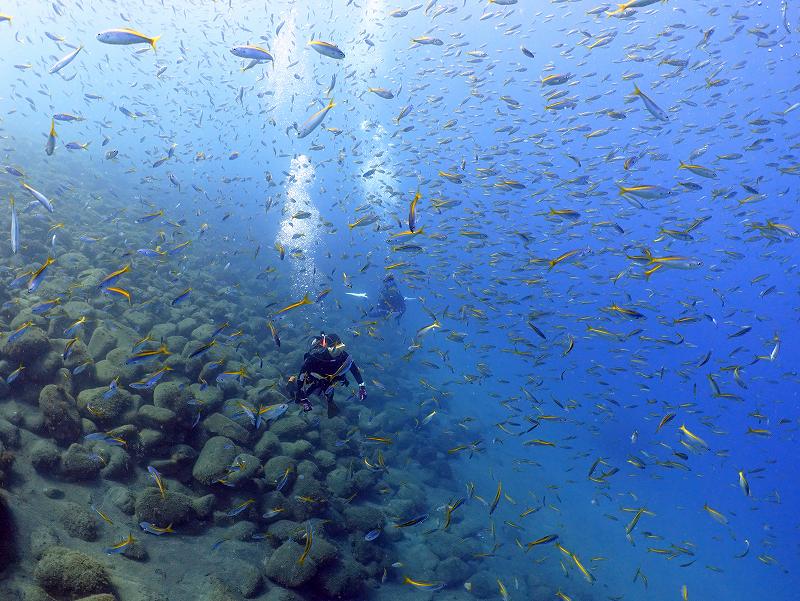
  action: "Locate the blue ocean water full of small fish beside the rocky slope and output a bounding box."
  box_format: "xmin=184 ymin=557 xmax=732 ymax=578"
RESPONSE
xmin=0 ymin=0 xmax=800 ymax=600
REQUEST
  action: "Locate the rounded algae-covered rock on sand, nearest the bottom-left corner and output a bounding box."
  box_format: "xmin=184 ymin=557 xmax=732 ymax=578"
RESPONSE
xmin=34 ymin=547 xmax=112 ymax=599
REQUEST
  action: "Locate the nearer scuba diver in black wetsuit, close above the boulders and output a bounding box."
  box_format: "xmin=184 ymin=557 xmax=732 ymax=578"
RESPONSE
xmin=295 ymin=332 xmax=367 ymax=417
